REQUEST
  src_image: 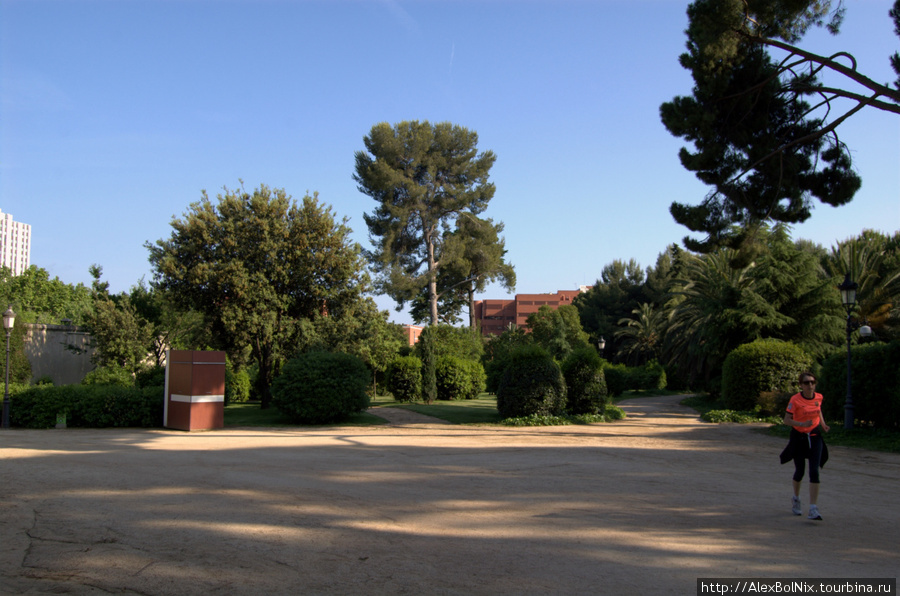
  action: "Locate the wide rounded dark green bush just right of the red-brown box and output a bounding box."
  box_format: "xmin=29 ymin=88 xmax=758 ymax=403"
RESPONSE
xmin=272 ymin=352 xmax=371 ymax=424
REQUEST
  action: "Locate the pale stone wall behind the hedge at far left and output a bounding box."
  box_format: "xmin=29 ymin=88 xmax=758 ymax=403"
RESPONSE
xmin=25 ymin=324 xmax=94 ymax=385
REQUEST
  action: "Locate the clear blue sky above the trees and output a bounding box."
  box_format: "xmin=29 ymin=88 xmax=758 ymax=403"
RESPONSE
xmin=0 ymin=0 xmax=900 ymax=322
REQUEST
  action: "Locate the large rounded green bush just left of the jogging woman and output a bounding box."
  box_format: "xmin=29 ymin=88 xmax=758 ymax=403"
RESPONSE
xmin=722 ymin=339 xmax=812 ymax=410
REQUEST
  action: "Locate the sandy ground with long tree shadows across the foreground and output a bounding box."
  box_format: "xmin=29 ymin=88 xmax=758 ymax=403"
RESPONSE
xmin=0 ymin=397 xmax=900 ymax=595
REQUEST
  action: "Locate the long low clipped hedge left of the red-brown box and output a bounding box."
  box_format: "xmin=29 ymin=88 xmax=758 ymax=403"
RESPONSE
xmin=10 ymin=385 xmax=164 ymax=428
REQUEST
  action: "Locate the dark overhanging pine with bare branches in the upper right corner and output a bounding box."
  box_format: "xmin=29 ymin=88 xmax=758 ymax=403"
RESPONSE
xmin=660 ymin=0 xmax=900 ymax=251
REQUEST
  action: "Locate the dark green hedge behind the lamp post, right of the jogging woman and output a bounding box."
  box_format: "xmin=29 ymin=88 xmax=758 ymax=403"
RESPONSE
xmin=816 ymin=341 xmax=900 ymax=429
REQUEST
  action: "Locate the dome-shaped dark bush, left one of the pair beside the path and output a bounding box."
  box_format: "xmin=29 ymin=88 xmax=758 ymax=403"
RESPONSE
xmin=497 ymin=346 xmax=566 ymax=418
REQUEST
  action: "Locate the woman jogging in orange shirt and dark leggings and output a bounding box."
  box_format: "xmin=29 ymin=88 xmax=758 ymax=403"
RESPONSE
xmin=781 ymin=372 xmax=829 ymax=520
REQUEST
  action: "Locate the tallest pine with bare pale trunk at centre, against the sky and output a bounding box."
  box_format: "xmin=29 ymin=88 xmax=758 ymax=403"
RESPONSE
xmin=353 ymin=121 xmax=496 ymax=325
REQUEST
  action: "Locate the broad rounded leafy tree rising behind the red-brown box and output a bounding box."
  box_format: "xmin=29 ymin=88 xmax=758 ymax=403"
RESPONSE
xmin=146 ymin=185 xmax=367 ymax=408
